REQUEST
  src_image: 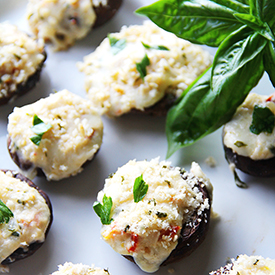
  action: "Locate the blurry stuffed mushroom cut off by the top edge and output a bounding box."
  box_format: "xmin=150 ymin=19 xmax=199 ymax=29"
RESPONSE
xmin=27 ymin=0 xmax=122 ymax=51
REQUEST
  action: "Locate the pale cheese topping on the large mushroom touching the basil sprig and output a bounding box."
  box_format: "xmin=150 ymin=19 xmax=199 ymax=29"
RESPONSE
xmin=78 ymin=21 xmax=211 ymax=116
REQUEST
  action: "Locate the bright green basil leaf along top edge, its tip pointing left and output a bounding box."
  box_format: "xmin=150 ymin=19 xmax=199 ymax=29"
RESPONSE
xmin=136 ymin=0 xmax=245 ymax=47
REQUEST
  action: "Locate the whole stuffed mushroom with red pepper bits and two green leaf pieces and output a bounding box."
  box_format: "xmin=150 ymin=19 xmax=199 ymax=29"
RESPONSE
xmin=93 ymin=158 xmax=212 ymax=272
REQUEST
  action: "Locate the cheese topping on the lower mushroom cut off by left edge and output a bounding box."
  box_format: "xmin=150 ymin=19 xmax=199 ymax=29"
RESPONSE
xmin=0 ymin=171 xmax=50 ymax=262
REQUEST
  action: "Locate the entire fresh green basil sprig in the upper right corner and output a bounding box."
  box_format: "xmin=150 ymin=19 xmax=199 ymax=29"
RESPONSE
xmin=136 ymin=0 xmax=275 ymax=157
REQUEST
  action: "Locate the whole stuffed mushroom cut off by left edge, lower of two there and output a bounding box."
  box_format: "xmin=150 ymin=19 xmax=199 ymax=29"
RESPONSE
xmin=0 ymin=170 xmax=53 ymax=265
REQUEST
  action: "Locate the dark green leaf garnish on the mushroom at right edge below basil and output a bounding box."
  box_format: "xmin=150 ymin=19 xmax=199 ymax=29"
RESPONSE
xmin=249 ymin=105 xmax=275 ymax=135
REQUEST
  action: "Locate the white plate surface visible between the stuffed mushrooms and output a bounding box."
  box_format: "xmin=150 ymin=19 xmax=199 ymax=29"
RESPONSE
xmin=0 ymin=0 xmax=275 ymax=275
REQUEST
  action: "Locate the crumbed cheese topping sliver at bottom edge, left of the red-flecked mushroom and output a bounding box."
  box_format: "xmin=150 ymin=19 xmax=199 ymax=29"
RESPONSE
xmin=51 ymin=262 xmax=109 ymax=275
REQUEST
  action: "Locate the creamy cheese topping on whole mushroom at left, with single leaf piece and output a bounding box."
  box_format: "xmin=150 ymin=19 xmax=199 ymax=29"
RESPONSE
xmin=8 ymin=90 xmax=103 ymax=180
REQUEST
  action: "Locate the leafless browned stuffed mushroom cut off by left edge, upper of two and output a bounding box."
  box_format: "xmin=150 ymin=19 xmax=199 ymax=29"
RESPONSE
xmin=0 ymin=22 xmax=46 ymax=105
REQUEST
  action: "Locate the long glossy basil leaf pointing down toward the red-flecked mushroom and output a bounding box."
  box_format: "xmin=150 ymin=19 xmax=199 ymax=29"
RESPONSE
xmin=166 ymin=28 xmax=266 ymax=157
